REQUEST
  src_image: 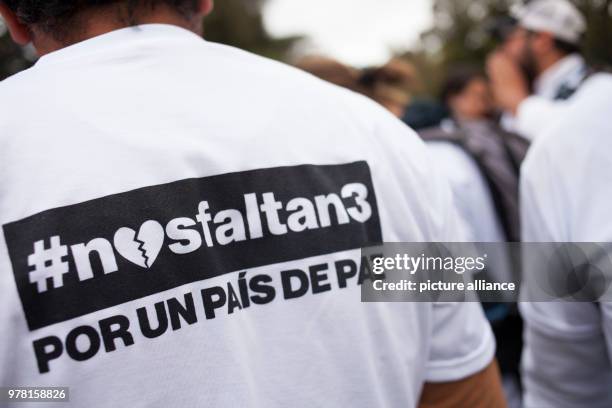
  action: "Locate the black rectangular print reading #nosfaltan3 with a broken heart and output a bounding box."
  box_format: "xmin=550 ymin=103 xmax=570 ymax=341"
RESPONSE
xmin=3 ymin=162 xmax=382 ymax=330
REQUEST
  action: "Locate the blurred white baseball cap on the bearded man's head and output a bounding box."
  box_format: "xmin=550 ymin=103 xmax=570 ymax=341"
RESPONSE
xmin=512 ymin=0 xmax=587 ymax=44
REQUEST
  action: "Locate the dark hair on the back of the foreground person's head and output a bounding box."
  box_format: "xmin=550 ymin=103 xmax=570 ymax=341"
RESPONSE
xmin=0 ymin=0 xmax=198 ymax=39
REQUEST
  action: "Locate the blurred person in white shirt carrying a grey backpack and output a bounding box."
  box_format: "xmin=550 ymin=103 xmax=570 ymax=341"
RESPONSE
xmin=419 ymin=66 xmax=528 ymax=407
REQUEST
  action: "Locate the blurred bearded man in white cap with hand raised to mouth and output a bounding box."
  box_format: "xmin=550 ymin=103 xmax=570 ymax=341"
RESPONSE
xmin=488 ymin=0 xmax=589 ymax=140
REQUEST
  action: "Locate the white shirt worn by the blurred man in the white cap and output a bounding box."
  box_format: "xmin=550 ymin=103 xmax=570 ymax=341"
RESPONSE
xmin=506 ymin=54 xmax=586 ymax=141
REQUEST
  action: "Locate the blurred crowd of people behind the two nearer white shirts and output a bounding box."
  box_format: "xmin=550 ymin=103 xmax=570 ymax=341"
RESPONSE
xmin=296 ymin=0 xmax=612 ymax=407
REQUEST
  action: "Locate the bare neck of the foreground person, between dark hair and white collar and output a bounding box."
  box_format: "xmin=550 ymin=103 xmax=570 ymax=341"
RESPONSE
xmin=32 ymin=9 xmax=202 ymax=56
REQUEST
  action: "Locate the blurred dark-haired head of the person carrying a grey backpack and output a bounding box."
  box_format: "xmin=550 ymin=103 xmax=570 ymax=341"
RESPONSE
xmin=441 ymin=67 xmax=493 ymax=120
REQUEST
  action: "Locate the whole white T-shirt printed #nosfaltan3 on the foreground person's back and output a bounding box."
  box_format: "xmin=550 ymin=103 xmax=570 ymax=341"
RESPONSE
xmin=0 ymin=25 xmax=494 ymax=407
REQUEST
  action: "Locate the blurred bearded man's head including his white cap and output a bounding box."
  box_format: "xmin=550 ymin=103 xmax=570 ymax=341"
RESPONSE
xmin=502 ymin=0 xmax=586 ymax=78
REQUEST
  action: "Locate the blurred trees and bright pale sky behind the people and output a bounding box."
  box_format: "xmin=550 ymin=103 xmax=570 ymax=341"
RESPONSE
xmin=0 ymin=0 xmax=612 ymax=95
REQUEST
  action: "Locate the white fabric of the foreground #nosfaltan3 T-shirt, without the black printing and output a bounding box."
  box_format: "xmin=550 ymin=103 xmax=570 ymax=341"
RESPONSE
xmin=0 ymin=25 xmax=494 ymax=407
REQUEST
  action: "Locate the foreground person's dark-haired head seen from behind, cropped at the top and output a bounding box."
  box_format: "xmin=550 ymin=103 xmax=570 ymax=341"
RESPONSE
xmin=0 ymin=0 xmax=213 ymax=54
